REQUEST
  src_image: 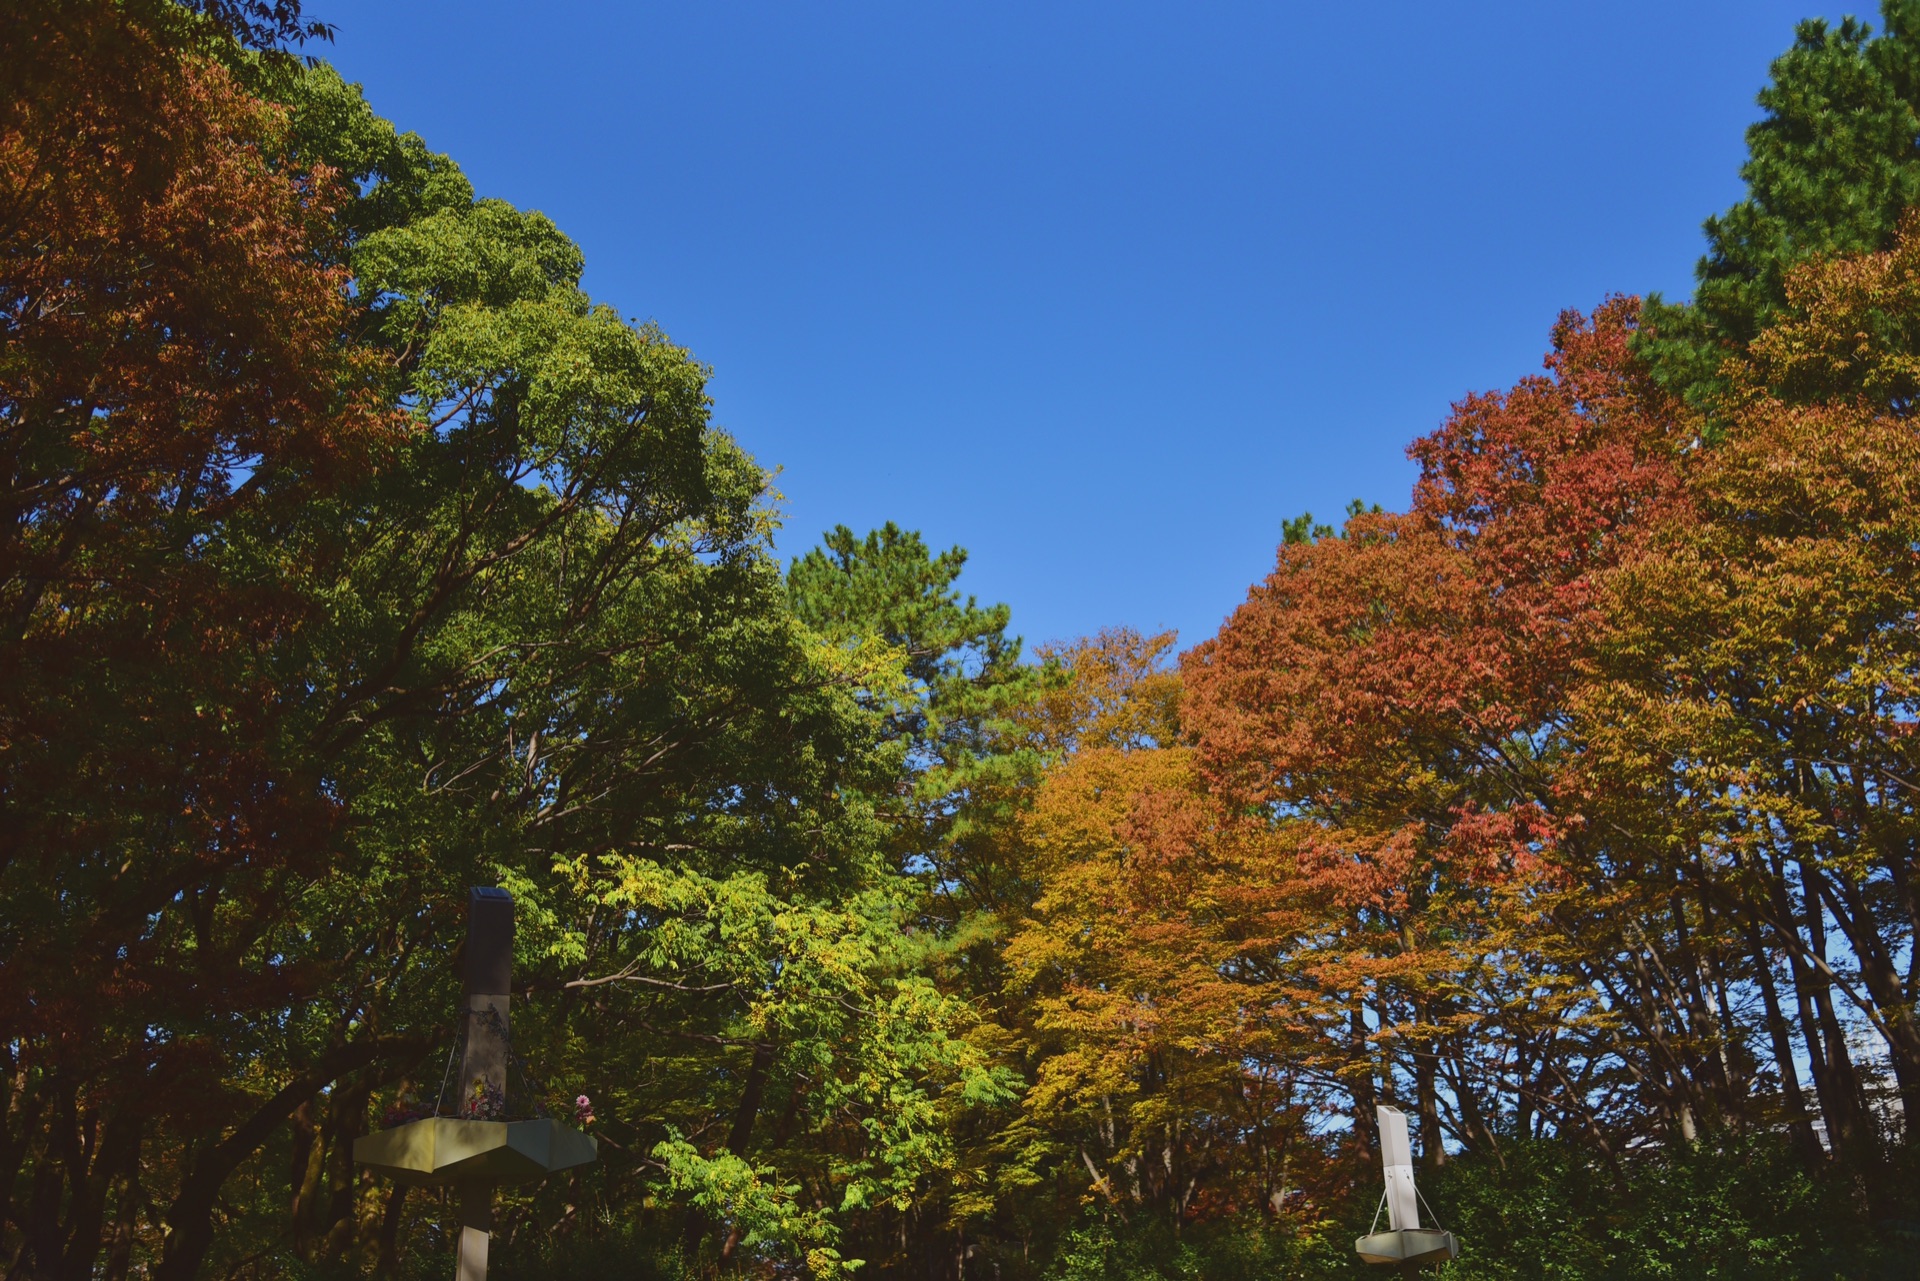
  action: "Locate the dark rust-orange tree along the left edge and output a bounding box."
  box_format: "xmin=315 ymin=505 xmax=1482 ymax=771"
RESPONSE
xmin=0 ymin=0 xmax=399 ymax=1275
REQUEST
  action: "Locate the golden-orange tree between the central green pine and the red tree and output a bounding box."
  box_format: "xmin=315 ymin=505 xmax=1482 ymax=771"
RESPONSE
xmin=960 ymin=628 xmax=1327 ymax=1233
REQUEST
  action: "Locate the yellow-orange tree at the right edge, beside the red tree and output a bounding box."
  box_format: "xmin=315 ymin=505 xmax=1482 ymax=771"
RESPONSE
xmin=1571 ymin=219 xmax=1920 ymax=1162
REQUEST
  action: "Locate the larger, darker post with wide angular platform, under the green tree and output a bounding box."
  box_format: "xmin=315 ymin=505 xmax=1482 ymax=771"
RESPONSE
xmin=353 ymin=885 xmax=599 ymax=1281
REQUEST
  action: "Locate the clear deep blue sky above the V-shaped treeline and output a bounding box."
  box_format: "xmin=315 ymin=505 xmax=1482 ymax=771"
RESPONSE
xmin=307 ymin=0 xmax=1827 ymax=645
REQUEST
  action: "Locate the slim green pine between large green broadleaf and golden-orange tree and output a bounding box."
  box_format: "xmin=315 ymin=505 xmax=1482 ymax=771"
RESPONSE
xmin=787 ymin=522 xmax=1064 ymax=1271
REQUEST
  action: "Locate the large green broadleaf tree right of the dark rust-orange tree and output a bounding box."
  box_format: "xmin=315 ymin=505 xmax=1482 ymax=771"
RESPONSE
xmin=243 ymin=69 xmax=1006 ymax=1273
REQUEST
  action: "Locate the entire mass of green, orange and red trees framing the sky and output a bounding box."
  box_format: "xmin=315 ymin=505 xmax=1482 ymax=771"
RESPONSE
xmin=11 ymin=0 xmax=1920 ymax=1281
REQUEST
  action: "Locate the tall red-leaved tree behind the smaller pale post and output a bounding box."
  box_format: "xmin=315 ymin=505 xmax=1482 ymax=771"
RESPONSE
xmin=1183 ymin=300 xmax=1682 ymax=1160
